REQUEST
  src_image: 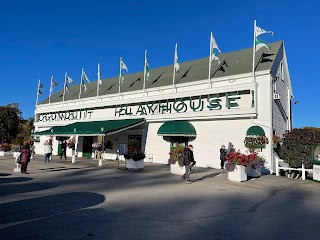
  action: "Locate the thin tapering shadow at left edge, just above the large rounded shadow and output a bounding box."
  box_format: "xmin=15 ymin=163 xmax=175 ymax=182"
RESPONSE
xmin=0 ymin=182 xmax=60 ymax=196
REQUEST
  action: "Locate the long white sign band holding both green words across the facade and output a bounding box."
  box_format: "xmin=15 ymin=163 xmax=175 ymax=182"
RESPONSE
xmin=37 ymin=90 xmax=254 ymax=122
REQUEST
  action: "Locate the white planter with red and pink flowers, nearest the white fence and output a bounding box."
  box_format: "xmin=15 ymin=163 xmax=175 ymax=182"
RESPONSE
xmin=226 ymin=151 xmax=264 ymax=182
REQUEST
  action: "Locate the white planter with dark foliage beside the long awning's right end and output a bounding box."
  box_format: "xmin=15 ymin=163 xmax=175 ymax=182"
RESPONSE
xmin=124 ymin=139 xmax=146 ymax=169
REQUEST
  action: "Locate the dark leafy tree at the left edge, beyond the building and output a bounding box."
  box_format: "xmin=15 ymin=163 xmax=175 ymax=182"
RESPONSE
xmin=0 ymin=103 xmax=22 ymax=143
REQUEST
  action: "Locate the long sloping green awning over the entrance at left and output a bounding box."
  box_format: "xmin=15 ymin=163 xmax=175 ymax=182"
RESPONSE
xmin=34 ymin=118 xmax=145 ymax=136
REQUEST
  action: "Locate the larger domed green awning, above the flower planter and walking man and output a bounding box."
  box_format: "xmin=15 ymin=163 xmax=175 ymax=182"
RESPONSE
xmin=157 ymin=120 xmax=197 ymax=137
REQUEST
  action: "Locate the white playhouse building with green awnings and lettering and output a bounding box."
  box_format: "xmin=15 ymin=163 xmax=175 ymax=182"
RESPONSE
xmin=35 ymin=42 xmax=293 ymax=172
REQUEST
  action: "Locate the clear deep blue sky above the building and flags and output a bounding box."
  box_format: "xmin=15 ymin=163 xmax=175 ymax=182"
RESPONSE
xmin=0 ymin=0 xmax=320 ymax=127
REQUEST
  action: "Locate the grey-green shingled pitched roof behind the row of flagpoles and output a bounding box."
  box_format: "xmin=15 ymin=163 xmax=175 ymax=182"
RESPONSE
xmin=40 ymin=41 xmax=283 ymax=104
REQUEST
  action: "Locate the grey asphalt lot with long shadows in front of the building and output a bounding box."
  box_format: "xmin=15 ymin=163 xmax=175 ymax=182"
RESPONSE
xmin=0 ymin=156 xmax=320 ymax=240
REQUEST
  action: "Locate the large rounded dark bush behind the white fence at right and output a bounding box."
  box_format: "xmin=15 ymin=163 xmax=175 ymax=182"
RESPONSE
xmin=279 ymin=127 xmax=320 ymax=168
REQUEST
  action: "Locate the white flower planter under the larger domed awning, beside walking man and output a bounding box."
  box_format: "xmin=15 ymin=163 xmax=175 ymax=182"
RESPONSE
xmin=168 ymin=144 xmax=186 ymax=175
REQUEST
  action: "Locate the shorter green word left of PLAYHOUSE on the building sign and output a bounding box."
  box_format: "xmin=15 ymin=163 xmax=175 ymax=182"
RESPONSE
xmin=38 ymin=109 xmax=93 ymax=122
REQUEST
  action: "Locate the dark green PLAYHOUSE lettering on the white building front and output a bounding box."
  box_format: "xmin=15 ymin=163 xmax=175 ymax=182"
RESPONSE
xmin=114 ymin=92 xmax=241 ymax=117
